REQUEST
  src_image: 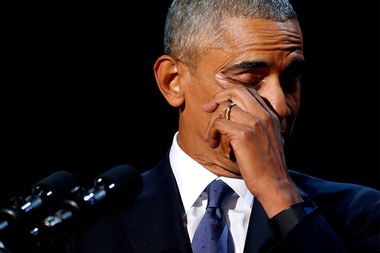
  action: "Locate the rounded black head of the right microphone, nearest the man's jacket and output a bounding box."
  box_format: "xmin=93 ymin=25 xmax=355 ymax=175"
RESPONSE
xmin=94 ymin=164 xmax=142 ymax=202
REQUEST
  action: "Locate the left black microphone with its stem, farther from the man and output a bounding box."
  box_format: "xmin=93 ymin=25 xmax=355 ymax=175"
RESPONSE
xmin=0 ymin=170 xmax=77 ymax=238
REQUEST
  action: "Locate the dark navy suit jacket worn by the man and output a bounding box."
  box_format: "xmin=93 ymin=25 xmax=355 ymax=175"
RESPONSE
xmin=66 ymin=154 xmax=380 ymax=253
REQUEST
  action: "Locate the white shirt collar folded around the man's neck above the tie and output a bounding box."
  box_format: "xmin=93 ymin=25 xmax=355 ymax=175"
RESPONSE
xmin=169 ymin=132 xmax=253 ymax=213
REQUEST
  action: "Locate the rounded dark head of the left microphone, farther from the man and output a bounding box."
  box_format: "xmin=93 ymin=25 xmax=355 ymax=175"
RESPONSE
xmin=32 ymin=170 xmax=78 ymax=198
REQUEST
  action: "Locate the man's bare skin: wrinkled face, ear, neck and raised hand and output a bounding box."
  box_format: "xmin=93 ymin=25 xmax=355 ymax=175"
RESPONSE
xmin=154 ymin=19 xmax=304 ymax=217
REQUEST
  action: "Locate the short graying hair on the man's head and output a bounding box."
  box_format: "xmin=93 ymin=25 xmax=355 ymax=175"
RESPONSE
xmin=164 ymin=0 xmax=297 ymax=67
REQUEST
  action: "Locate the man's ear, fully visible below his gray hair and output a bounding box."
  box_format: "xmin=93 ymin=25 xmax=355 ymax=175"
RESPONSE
xmin=154 ymin=55 xmax=184 ymax=107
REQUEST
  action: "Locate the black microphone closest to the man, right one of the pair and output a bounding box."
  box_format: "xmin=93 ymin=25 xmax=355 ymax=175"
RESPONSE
xmin=30 ymin=164 xmax=142 ymax=240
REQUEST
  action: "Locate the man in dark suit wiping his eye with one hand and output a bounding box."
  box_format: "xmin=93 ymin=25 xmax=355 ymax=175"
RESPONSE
xmin=67 ymin=0 xmax=380 ymax=253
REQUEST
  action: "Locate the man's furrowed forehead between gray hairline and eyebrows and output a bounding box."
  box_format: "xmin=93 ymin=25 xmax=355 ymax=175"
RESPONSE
xmin=194 ymin=18 xmax=303 ymax=70
